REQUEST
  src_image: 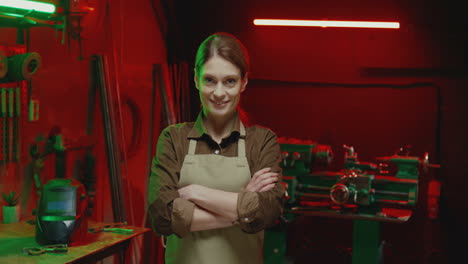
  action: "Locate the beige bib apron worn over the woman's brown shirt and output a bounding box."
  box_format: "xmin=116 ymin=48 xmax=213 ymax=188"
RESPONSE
xmin=165 ymin=124 xmax=263 ymax=264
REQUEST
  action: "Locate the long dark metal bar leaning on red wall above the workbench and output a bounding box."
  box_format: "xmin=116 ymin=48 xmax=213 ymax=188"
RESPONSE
xmin=91 ymin=55 xmax=126 ymax=222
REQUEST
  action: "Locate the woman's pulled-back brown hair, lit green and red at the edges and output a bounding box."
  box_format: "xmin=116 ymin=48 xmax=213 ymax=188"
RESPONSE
xmin=195 ymin=32 xmax=251 ymax=126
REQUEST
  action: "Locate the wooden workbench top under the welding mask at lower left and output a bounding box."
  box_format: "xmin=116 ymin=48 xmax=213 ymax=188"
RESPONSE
xmin=0 ymin=222 xmax=150 ymax=264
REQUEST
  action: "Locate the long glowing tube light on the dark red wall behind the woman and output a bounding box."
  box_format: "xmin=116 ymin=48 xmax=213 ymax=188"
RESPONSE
xmin=253 ymin=19 xmax=400 ymax=29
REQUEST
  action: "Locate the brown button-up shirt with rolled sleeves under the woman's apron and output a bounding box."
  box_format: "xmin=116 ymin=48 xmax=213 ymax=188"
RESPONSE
xmin=148 ymin=113 xmax=285 ymax=237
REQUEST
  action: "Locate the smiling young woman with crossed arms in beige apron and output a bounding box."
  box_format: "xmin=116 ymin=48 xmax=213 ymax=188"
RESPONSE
xmin=148 ymin=33 xmax=285 ymax=264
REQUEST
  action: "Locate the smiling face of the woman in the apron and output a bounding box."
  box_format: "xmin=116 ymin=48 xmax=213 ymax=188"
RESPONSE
xmin=195 ymin=55 xmax=247 ymax=118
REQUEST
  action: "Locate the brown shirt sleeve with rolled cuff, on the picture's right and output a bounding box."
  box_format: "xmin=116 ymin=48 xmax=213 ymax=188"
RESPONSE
xmin=237 ymin=129 xmax=285 ymax=233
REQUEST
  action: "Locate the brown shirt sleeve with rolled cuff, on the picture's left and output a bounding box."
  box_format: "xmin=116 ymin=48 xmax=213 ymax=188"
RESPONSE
xmin=148 ymin=127 xmax=195 ymax=237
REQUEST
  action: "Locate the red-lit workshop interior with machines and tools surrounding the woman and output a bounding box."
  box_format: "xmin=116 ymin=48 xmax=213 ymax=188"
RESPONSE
xmin=0 ymin=0 xmax=468 ymax=264
